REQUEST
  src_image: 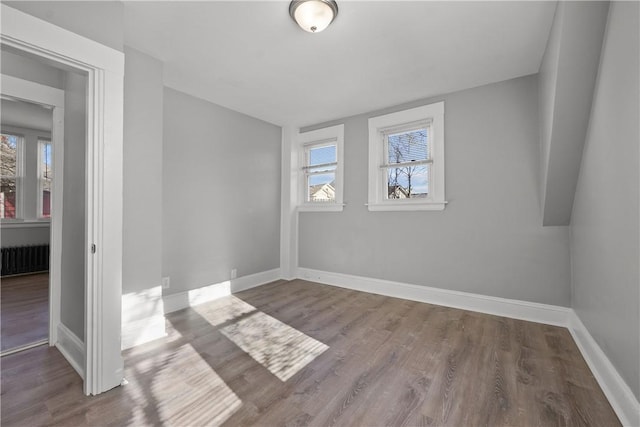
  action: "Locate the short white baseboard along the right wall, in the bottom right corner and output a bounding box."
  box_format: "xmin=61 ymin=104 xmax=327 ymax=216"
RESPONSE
xmin=568 ymin=310 xmax=640 ymax=426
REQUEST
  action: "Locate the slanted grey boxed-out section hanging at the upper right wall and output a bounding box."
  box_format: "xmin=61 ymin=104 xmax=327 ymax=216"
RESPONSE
xmin=539 ymin=2 xmax=609 ymax=226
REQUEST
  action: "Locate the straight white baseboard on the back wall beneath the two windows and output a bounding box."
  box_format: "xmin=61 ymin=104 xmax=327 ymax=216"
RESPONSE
xmin=298 ymin=268 xmax=571 ymax=326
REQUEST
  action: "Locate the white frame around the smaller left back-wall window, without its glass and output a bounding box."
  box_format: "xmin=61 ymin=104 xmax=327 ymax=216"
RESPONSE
xmin=297 ymin=124 xmax=344 ymax=212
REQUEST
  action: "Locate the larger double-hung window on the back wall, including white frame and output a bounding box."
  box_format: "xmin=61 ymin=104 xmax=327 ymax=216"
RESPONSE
xmin=368 ymin=102 xmax=446 ymax=211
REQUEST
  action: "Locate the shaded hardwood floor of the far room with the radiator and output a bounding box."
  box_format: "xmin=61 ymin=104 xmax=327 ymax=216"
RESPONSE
xmin=0 ymin=273 xmax=49 ymax=351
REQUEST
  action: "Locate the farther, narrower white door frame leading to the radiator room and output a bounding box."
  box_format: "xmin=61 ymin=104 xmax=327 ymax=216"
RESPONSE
xmin=0 ymin=74 xmax=64 ymax=352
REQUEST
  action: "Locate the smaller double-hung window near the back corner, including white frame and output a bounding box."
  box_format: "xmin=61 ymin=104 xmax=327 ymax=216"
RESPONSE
xmin=298 ymin=125 xmax=344 ymax=211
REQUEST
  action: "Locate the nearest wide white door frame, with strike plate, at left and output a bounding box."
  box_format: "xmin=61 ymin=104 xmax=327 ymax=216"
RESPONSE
xmin=0 ymin=4 xmax=124 ymax=394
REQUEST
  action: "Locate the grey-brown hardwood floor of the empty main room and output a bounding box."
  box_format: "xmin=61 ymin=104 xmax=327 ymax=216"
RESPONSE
xmin=1 ymin=280 xmax=620 ymax=426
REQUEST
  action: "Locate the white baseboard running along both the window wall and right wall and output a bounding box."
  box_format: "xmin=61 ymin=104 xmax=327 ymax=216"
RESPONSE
xmin=297 ymin=268 xmax=640 ymax=426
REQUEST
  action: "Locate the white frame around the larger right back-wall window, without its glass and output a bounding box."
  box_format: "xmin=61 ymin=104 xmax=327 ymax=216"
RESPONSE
xmin=367 ymin=102 xmax=447 ymax=211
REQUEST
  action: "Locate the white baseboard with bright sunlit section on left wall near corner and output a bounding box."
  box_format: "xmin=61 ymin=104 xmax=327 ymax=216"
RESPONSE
xmin=163 ymin=268 xmax=280 ymax=314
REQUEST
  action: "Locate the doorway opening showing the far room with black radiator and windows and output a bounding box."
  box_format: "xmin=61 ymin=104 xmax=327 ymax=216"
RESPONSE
xmin=0 ymin=98 xmax=53 ymax=356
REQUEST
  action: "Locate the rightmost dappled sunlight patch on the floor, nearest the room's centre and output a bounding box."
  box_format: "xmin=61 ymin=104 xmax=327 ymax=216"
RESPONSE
xmin=220 ymin=303 xmax=329 ymax=381
